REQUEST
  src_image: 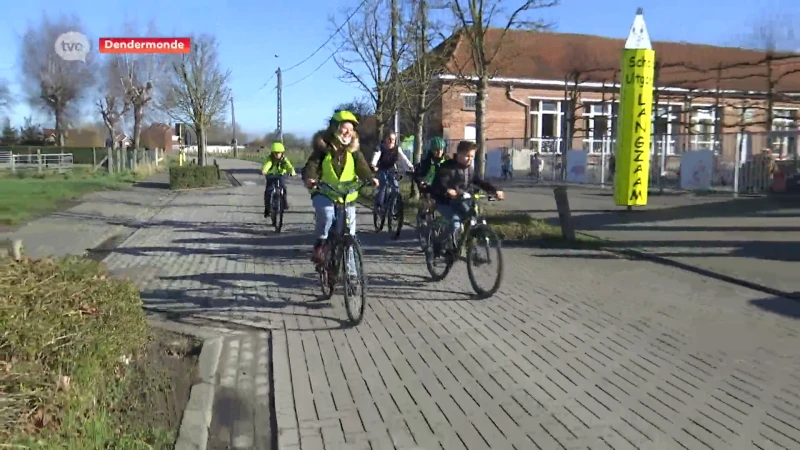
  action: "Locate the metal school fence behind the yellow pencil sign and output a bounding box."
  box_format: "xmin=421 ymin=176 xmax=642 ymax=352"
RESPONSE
xmin=478 ymin=131 xmax=800 ymax=194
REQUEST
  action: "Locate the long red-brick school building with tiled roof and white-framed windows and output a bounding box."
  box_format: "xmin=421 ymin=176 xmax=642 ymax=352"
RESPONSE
xmin=418 ymin=29 xmax=800 ymax=163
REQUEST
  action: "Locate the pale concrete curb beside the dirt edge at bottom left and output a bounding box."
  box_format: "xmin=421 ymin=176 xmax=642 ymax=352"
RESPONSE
xmin=173 ymin=337 xmax=223 ymax=450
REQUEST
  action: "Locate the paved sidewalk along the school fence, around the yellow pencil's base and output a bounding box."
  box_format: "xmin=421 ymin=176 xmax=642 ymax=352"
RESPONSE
xmin=494 ymin=179 xmax=800 ymax=295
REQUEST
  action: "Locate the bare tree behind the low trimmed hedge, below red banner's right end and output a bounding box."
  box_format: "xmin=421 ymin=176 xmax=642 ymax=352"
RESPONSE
xmin=160 ymin=34 xmax=231 ymax=165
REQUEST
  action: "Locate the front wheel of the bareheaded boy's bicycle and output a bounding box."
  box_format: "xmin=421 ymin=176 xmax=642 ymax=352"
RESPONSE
xmin=466 ymin=225 xmax=503 ymax=298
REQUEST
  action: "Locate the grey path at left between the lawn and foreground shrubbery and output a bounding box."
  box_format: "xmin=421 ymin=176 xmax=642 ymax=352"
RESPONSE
xmin=0 ymin=173 xmax=175 ymax=258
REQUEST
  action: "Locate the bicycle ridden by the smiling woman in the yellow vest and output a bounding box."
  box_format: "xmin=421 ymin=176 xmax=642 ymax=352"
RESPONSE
xmin=316 ymin=181 xmax=369 ymax=325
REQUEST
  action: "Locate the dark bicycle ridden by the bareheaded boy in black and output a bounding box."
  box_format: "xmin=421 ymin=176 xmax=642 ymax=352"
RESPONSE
xmin=425 ymin=190 xmax=503 ymax=298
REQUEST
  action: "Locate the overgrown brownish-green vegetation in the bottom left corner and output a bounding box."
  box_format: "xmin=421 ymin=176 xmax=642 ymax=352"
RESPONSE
xmin=0 ymin=257 xmax=174 ymax=450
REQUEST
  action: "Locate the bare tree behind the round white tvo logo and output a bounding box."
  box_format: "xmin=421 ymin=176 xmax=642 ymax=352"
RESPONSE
xmin=20 ymin=15 xmax=95 ymax=147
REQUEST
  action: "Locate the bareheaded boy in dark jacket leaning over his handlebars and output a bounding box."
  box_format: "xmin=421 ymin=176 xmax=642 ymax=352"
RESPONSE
xmin=429 ymin=141 xmax=505 ymax=246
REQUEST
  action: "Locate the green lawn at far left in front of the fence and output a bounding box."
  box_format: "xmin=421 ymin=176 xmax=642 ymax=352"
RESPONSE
xmin=0 ymin=166 xmax=146 ymax=225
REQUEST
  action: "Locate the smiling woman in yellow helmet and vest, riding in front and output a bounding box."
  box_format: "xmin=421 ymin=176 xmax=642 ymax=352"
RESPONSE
xmin=303 ymin=111 xmax=380 ymax=263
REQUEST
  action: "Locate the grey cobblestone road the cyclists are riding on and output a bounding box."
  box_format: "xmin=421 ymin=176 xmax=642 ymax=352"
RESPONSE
xmin=106 ymin=161 xmax=800 ymax=450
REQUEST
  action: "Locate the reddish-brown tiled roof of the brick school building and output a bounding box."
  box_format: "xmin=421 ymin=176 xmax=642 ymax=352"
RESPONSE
xmin=434 ymin=28 xmax=800 ymax=92
